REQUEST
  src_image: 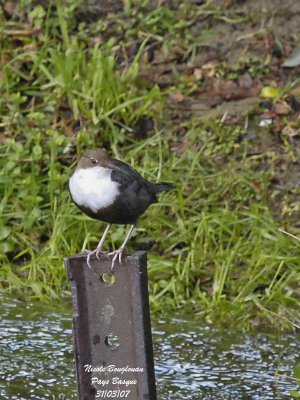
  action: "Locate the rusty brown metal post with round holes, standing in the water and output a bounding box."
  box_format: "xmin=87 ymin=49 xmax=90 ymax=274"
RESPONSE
xmin=65 ymin=252 xmax=156 ymax=400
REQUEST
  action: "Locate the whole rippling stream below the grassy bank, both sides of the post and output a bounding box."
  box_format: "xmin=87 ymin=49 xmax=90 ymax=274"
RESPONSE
xmin=0 ymin=297 xmax=300 ymax=400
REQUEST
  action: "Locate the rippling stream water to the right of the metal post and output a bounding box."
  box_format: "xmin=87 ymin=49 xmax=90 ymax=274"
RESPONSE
xmin=154 ymin=319 xmax=300 ymax=400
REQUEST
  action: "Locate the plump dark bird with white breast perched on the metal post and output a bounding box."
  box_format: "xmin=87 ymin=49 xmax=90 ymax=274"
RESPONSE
xmin=69 ymin=149 xmax=174 ymax=269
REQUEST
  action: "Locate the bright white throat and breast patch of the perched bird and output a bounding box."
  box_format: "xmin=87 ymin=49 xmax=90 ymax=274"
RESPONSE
xmin=69 ymin=166 xmax=119 ymax=212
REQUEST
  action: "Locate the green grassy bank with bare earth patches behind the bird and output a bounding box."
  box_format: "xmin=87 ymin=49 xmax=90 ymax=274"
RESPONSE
xmin=0 ymin=1 xmax=300 ymax=327
